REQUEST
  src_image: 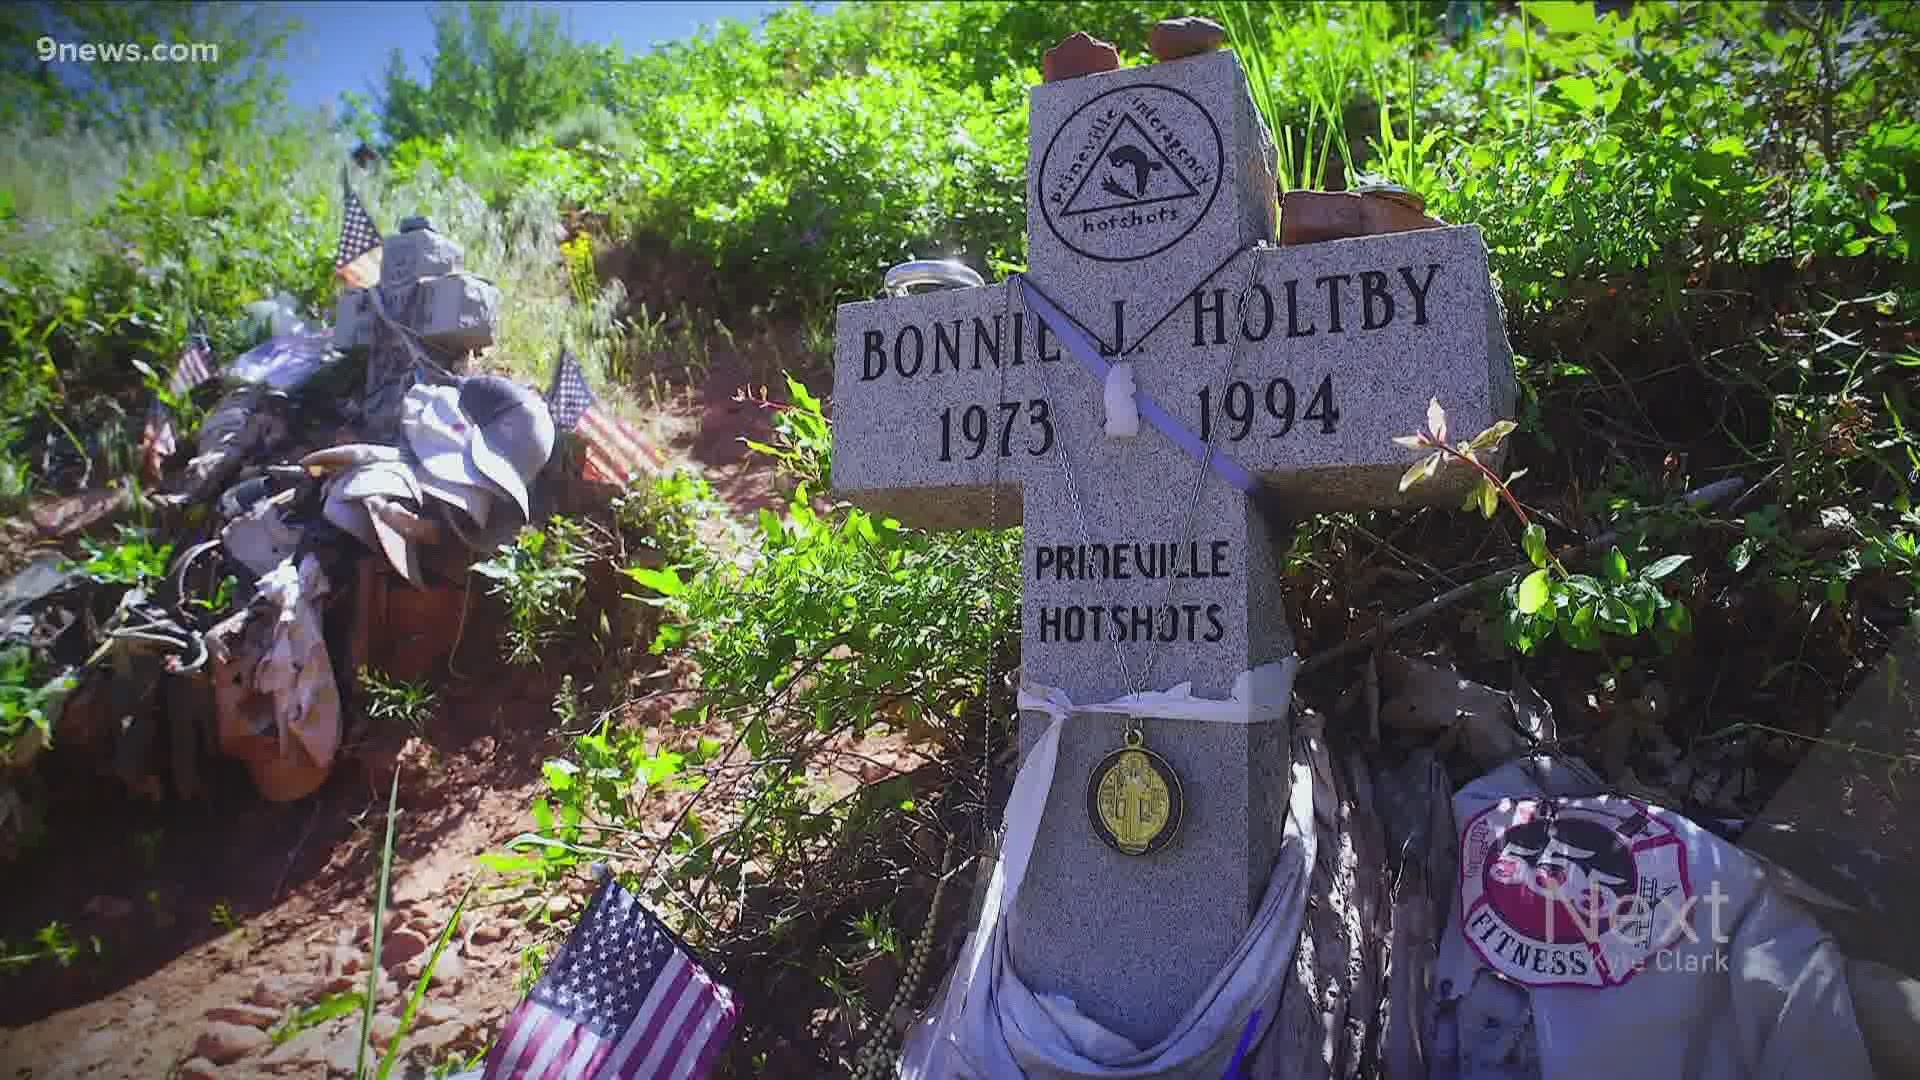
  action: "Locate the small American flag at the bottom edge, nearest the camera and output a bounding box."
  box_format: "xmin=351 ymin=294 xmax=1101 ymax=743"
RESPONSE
xmin=482 ymin=876 xmax=739 ymax=1080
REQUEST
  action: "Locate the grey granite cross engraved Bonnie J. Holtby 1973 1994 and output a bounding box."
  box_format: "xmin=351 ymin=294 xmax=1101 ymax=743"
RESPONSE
xmin=833 ymin=52 xmax=1515 ymax=1047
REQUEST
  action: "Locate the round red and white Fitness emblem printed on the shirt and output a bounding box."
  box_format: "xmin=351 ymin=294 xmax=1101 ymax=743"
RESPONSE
xmin=1459 ymin=799 xmax=1692 ymax=988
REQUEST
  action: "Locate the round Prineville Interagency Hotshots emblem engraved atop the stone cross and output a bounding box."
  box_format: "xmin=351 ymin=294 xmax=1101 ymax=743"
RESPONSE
xmin=1039 ymin=83 xmax=1223 ymax=263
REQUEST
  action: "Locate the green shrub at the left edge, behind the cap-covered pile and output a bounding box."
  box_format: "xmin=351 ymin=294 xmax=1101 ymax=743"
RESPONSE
xmin=0 ymin=119 xmax=338 ymax=486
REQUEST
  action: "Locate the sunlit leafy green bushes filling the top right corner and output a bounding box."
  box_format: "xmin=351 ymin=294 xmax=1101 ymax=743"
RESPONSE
xmin=1382 ymin=4 xmax=1920 ymax=313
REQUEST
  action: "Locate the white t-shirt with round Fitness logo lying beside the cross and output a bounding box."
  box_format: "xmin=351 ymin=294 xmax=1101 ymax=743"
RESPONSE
xmin=1428 ymin=759 xmax=1872 ymax=1080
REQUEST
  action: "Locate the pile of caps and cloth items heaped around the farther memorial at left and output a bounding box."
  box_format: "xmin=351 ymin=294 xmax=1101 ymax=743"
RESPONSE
xmin=0 ymin=208 xmax=633 ymax=857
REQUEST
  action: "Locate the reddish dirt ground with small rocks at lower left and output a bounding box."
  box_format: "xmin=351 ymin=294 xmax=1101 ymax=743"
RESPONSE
xmin=0 ymin=356 xmax=794 ymax=1080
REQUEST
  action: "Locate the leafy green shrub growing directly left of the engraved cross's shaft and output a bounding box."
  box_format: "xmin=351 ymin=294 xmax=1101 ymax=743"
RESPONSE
xmin=493 ymin=374 xmax=1020 ymax=920
